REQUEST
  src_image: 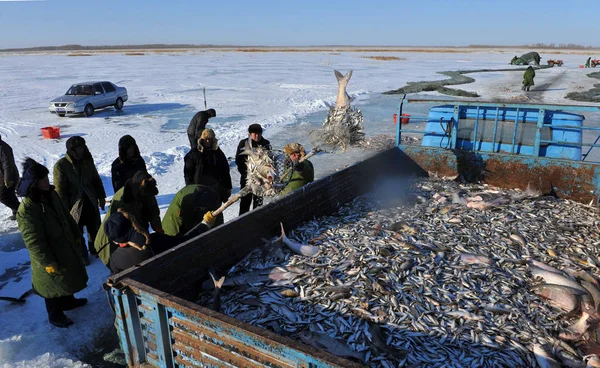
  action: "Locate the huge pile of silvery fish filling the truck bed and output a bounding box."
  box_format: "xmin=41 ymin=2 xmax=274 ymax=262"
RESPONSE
xmin=198 ymin=178 xmax=600 ymax=367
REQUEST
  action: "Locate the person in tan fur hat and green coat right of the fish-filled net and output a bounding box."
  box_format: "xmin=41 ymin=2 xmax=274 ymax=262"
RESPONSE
xmin=280 ymin=142 xmax=315 ymax=195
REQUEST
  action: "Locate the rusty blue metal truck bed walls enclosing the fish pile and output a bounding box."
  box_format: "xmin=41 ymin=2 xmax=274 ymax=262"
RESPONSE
xmin=106 ymin=146 xmax=600 ymax=367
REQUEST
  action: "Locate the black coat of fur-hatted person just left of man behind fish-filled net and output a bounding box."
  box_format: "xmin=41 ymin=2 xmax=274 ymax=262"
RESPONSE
xmin=183 ymin=148 xmax=232 ymax=202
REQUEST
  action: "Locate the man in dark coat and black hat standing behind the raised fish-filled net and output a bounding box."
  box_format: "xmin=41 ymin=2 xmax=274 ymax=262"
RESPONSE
xmin=235 ymin=124 xmax=271 ymax=215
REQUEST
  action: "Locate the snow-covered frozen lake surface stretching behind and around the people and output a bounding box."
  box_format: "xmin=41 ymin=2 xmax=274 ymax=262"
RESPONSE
xmin=0 ymin=50 xmax=600 ymax=367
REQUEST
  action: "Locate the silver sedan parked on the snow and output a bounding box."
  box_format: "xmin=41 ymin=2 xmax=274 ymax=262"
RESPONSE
xmin=48 ymin=81 xmax=127 ymax=116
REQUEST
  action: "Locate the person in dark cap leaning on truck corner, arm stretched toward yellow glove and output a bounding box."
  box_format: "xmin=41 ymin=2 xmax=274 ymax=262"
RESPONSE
xmin=104 ymin=209 xmax=215 ymax=274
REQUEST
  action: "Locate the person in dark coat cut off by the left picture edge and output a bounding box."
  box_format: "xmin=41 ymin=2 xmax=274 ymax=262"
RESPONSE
xmin=0 ymin=137 xmax=19 ymax=220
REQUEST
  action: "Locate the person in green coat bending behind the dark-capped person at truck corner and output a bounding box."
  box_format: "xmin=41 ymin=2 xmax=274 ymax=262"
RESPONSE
xmin=94 ymin=170 xmax=163 ymax=267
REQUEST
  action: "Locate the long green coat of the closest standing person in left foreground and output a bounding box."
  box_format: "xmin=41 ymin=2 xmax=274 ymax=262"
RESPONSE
xmin=17 ymin=187 xmax=88 ymax=298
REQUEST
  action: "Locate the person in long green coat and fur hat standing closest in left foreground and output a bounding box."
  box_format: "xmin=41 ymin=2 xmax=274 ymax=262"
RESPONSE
xmin=17 ymin=158 xmax=88 ymax=328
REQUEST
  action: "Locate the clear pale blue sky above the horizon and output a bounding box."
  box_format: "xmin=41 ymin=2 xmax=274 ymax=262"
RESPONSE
xmin=0 ymin=0 xmax=600 ymax=48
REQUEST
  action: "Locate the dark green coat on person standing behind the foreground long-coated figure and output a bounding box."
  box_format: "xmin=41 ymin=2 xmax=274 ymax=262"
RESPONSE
xmin=54 ymin=152 xmax=106 ymax=222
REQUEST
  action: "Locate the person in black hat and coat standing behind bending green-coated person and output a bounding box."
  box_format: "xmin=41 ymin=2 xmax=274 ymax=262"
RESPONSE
xmin=111 ymin=135 xmax=148 ymax=193
